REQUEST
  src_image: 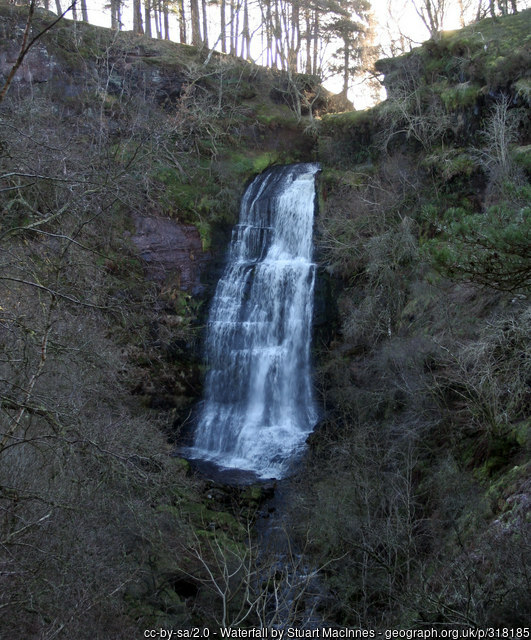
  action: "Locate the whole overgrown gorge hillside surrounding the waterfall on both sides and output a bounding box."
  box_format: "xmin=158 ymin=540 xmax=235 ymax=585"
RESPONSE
xmin=0 ymin=5 xmax=531 ymax=638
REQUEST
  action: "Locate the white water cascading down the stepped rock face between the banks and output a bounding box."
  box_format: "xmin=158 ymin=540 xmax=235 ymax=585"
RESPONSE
xmin=189 ymin=164 xmax=319 ymax=478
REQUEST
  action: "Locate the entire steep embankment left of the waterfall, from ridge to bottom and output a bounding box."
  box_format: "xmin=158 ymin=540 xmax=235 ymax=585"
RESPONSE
xmin=0 ymin=5 xmax=324 ymax=638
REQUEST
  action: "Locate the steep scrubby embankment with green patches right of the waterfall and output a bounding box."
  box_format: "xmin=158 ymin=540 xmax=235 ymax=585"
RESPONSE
xmin=289 ymin=12 xmax=531 ymax=628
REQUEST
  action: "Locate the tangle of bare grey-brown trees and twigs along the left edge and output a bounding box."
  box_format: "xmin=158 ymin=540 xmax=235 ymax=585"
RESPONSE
xmin=0 ymin=92 xmax=210 ymax=638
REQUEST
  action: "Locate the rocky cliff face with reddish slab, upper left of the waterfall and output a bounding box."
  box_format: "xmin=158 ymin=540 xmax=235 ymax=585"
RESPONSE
xmin=0 ymin=5 xmax=324 ymax=404
